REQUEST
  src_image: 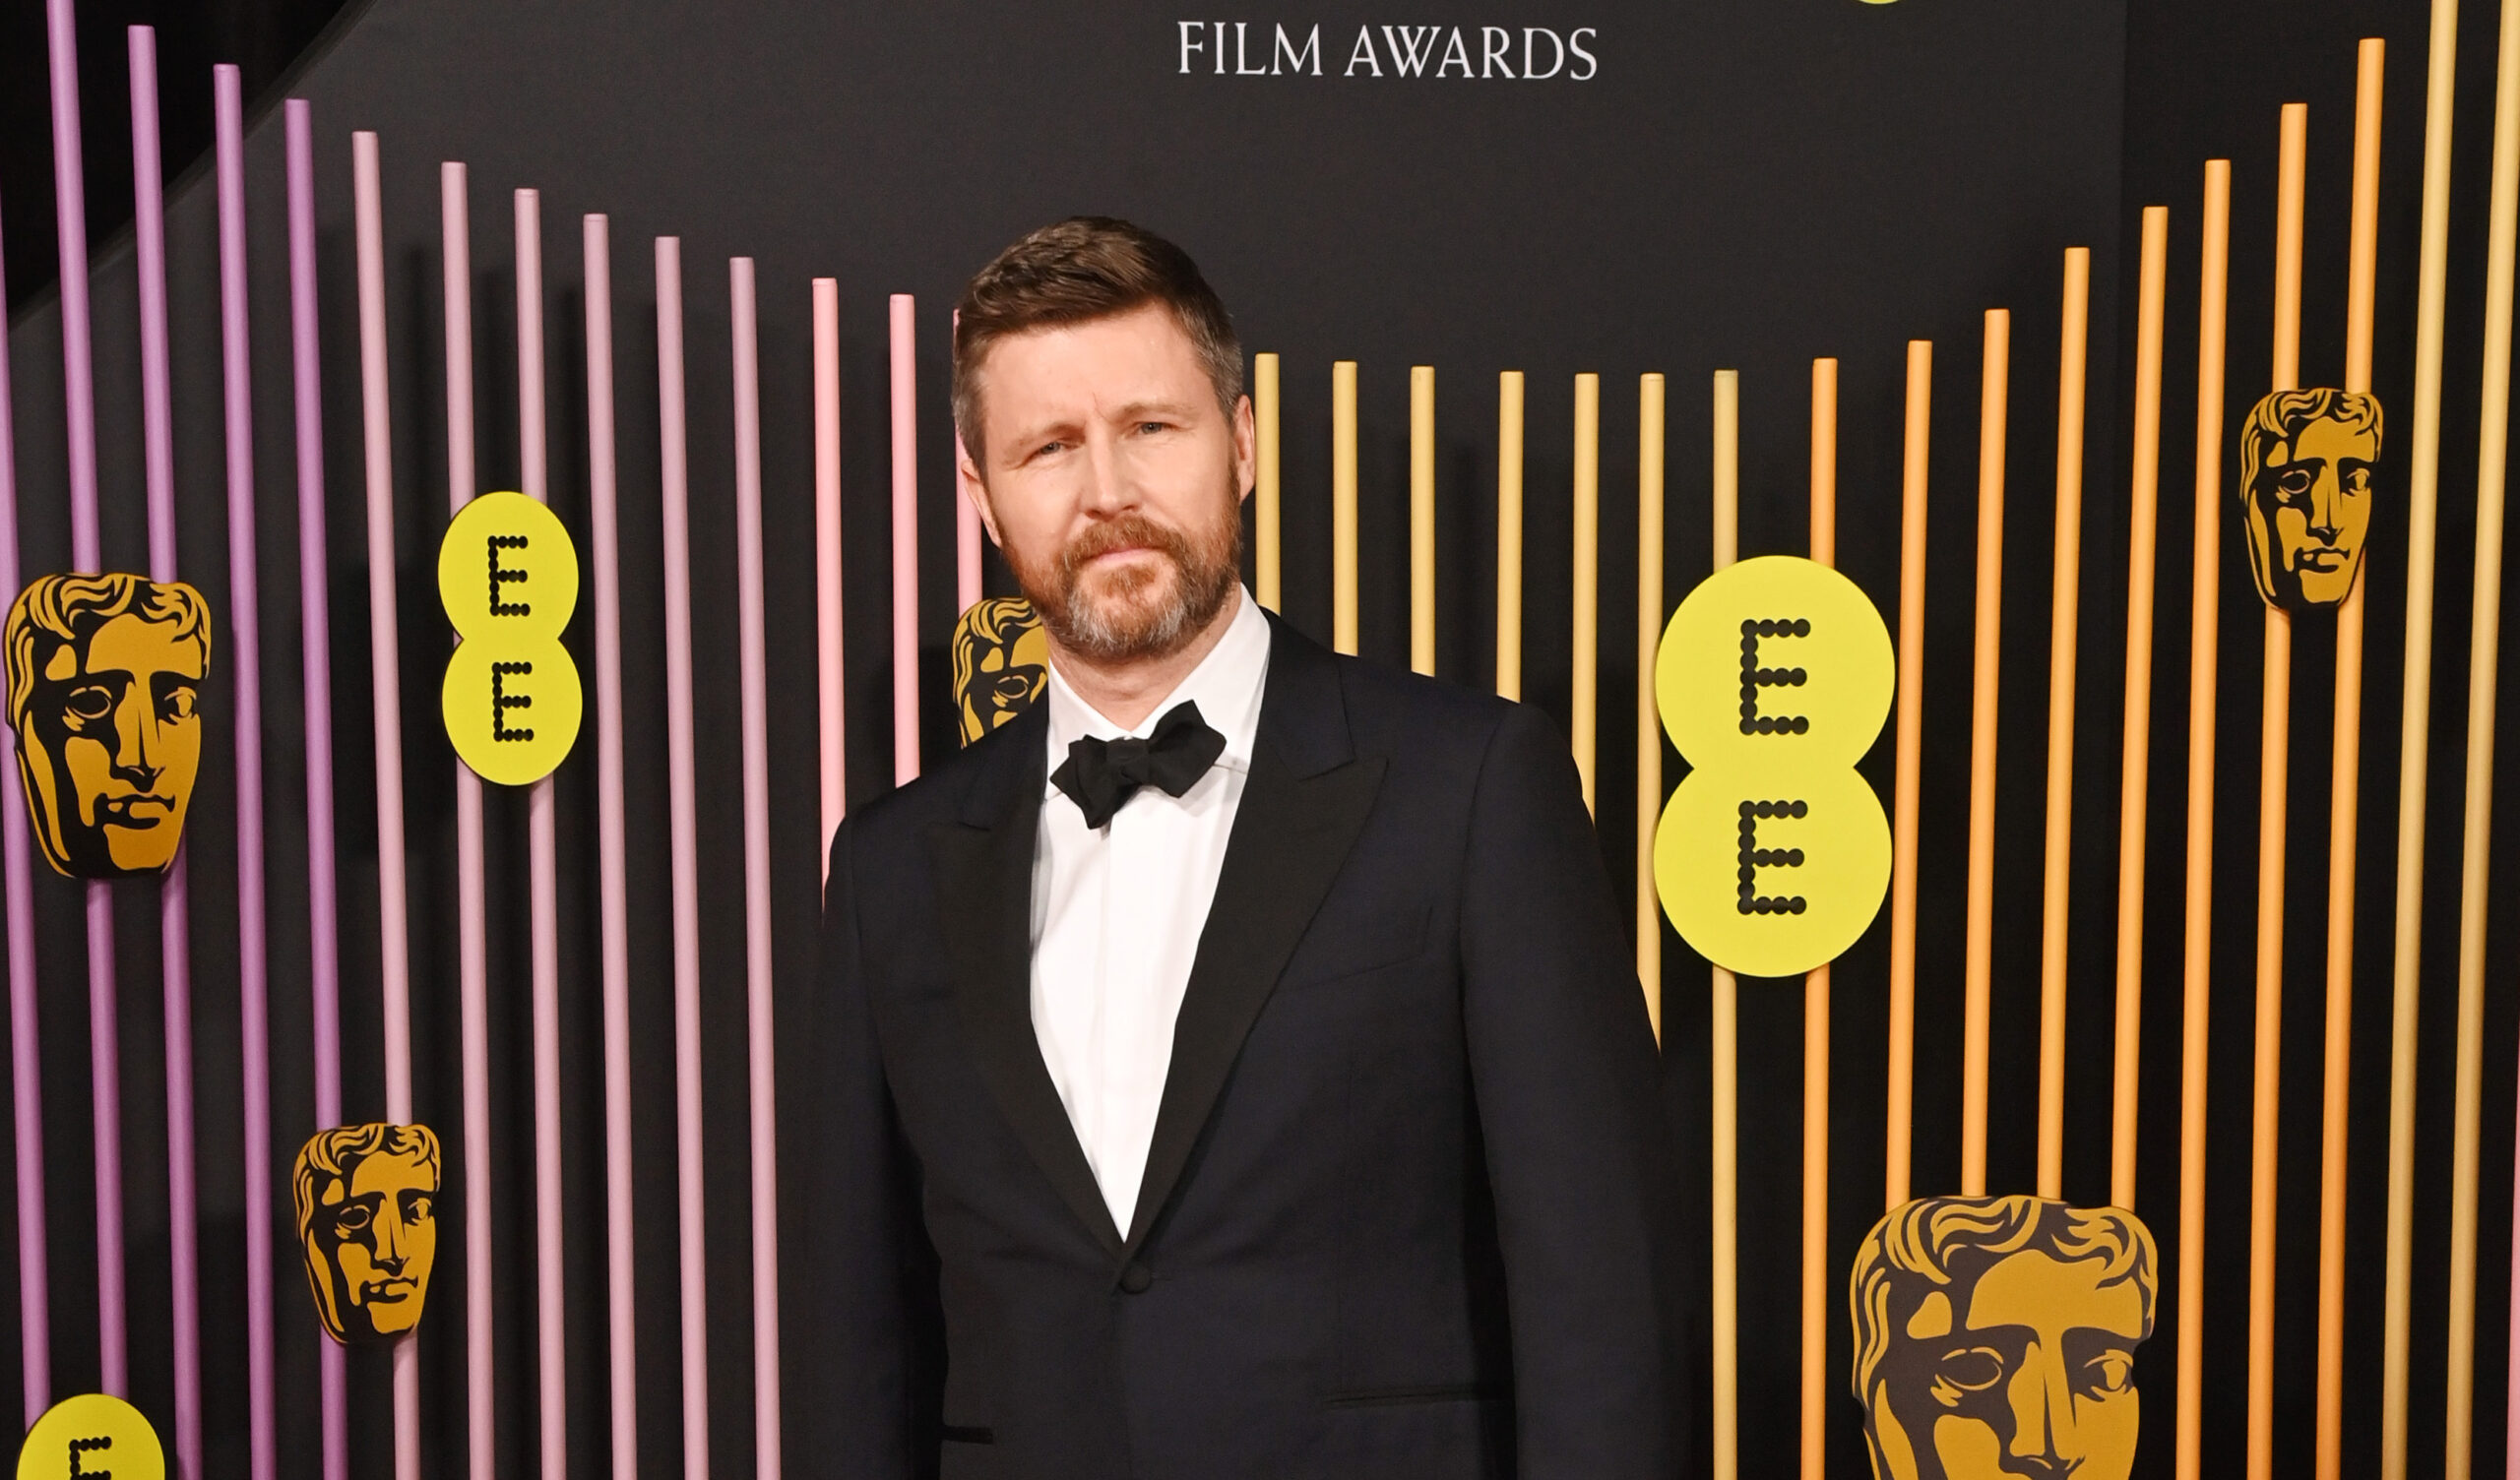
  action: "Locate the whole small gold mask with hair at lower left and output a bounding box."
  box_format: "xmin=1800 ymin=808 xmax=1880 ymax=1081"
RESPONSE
xmin=292 ymin=1125 xmax=438 ymax=1344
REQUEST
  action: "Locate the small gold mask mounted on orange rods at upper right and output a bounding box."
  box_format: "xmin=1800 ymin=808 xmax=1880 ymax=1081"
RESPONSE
xmin=2240 ymin=390 xmax=2379 ymax=612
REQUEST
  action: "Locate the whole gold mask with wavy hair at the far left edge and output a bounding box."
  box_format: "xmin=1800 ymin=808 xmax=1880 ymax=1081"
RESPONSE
xmin=8 ymin=574 xmax=209 ymax=879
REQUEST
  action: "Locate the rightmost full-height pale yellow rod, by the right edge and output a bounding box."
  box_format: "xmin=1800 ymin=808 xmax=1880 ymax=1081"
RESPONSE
xmin=2442 ymin=0 xmax=2520 ymax=1480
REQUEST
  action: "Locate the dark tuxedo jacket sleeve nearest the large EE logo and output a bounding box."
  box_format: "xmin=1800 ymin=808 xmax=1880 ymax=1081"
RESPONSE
xmin=1462 ymin=708 xmax=1681 ymax=1480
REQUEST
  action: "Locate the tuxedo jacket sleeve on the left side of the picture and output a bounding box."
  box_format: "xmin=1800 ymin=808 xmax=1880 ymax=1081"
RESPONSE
xmin=799 ymin=826 xmax=942 ymax=1480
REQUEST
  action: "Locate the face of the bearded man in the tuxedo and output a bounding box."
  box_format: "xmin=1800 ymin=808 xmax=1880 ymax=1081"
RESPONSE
xmin=963 ymin=304 xmax=1255 ymax=662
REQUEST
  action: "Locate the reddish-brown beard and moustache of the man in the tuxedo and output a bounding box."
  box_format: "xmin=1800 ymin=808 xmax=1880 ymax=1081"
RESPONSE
xmin=1005 ymin=501 xmax=1242 ymax=662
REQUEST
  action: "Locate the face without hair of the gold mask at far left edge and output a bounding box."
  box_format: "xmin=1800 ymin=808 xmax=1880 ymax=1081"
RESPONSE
xmin=20 ymin=612 xmax=202 ymax=879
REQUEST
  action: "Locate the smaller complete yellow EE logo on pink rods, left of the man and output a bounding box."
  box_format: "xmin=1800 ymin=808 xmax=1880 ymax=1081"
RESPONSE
xmin=438 ymin=493 xmax=587 ymax=785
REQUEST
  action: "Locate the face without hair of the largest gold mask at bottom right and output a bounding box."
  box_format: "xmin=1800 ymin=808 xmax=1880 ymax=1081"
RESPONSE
xmin=1872 ymin=1251 xmax=2145 ymax=1480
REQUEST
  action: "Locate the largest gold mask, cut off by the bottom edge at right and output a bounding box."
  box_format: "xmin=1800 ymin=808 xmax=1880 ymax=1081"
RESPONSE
xmin=1847 ymin=1199 xmax=2160 ymax=1480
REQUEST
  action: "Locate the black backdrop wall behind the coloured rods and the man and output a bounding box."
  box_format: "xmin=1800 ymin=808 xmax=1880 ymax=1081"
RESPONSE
xmin=0 ymin=0 xmax=2520 ymax=1475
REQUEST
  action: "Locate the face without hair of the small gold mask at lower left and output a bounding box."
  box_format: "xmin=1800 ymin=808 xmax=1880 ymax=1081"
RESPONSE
xmin=307 ymin=1152 xmax=438 ymax=1341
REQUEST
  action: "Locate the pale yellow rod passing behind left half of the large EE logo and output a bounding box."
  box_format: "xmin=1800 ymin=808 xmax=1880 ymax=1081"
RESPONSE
xmin=1706 ymin=370 xmax=1741 ymax=1480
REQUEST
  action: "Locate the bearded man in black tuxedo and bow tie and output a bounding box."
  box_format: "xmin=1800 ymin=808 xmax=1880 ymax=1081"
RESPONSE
xmin=806 ymin=219 xmax=1681 ymax=1480
